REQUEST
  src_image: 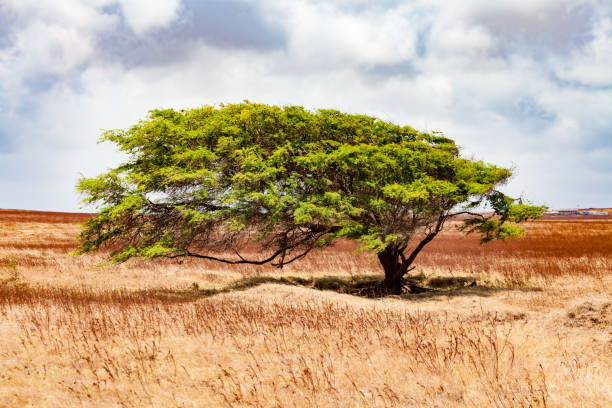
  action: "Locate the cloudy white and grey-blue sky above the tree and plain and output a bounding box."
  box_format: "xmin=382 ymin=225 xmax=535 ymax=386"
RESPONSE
xmin=0 ymin=0 xmax=612 ymax=211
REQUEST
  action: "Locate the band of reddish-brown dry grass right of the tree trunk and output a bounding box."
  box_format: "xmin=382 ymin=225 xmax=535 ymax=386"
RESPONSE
xmin=418 ymin=217 xmax=612 ymax=279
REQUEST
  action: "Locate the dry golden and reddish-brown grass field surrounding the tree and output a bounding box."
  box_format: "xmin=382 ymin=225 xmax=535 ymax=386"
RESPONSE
xmin=0 ymin=210 xmax=612 ymax=408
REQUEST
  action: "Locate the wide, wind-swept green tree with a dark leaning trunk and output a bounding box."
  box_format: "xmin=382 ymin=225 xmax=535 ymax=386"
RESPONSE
xmin=77 ymin=102 xmax=545 ymax=292
